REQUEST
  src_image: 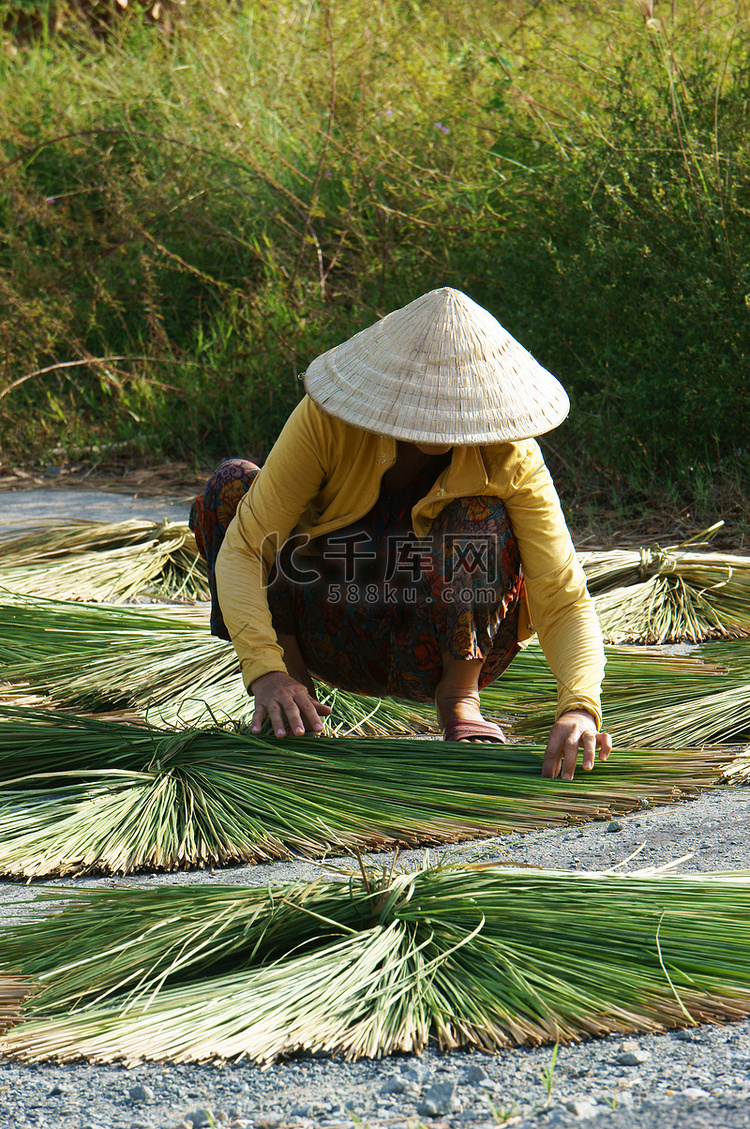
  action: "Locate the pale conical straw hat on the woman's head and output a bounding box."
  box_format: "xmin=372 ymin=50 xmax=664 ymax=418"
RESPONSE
xmin=305 ymin=287 xmax=570 ymax=446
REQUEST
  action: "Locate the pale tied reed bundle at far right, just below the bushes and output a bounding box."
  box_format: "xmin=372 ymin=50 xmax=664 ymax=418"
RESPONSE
xmin=578 ymin=522 xmax=750 ymax=644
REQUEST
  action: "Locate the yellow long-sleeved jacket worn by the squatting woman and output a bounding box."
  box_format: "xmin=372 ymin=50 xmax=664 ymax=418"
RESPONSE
xmin=216 ymin=396 xmax=604 ymax=725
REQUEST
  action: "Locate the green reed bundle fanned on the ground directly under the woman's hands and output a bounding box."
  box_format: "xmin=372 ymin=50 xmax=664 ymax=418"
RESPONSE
xmin=0 ymin=708 xmax=731 ymax=879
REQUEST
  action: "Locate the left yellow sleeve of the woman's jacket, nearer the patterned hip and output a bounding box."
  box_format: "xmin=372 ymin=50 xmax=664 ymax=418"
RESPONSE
xmin=216 ymin=396 xmax=330 ymax=689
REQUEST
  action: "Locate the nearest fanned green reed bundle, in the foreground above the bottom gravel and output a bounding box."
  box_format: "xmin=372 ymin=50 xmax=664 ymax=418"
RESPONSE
xmin=0 ymin=866 xmax=750 ymax=1064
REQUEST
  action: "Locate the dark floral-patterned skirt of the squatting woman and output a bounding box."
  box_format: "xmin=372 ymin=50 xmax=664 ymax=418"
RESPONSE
xmin=190 ymin=458 xmax=523 ymax=701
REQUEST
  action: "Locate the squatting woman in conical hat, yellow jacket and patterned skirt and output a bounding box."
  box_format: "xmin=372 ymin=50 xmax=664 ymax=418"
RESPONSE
xmin=191 ymin=288 xmax=611 ymax=780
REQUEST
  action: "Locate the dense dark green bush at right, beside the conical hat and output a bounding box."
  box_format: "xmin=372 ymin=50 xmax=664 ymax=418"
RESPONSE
xmin=474 ymin=7 xmax=750 ymax=503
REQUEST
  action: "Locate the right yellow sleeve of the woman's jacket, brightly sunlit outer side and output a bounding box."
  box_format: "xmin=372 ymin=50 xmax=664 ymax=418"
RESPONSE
xmin=504 ymin=443 xmax=604 ymax=727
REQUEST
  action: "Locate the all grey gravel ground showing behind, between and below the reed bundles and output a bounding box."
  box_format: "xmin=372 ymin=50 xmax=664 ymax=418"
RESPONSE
xmin=0 ymin=491 xmax=750 ymax=1129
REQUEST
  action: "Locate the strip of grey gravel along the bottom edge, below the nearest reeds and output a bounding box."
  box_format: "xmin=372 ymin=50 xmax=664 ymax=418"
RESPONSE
xmin=0 ymin=1023 xmax=750 ymax=1129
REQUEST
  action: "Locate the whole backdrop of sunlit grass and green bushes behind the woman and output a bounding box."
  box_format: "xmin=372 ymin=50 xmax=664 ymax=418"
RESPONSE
xmin=0 ymin=0 xmax=750 ymax=516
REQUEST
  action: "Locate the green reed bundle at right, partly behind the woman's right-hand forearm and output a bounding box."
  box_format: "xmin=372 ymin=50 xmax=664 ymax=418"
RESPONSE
xmin=480 ymin=639 xmax=750 ymax=749
